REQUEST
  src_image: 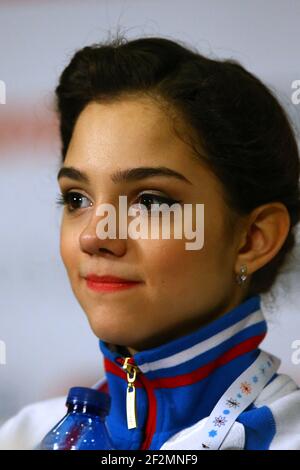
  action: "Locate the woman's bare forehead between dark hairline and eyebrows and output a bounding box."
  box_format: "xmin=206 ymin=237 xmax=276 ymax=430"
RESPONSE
xmin=64 ymin=97 xmax=220 ymax=197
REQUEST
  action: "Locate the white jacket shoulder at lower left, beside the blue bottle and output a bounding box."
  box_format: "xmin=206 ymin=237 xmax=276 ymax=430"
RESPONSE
xmin=0 ymin=396 xmax=66 ymax=450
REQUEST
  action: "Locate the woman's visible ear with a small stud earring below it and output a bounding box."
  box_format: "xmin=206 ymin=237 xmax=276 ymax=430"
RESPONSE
xmin=235 ymin=202 xmax=291 ymax=274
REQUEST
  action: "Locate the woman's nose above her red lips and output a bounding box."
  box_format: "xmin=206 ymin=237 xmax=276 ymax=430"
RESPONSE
xmin=79 ymin=206 xmax=127 ymax=256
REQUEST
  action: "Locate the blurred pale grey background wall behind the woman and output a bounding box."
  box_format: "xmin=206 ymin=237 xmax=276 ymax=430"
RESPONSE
xmin=0 ymin=0 xmax=300 ymax=422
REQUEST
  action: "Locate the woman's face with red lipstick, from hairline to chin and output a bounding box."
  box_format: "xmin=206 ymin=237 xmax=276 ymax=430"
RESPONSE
xmin=59 ymin=98 xmax=245 ymax=351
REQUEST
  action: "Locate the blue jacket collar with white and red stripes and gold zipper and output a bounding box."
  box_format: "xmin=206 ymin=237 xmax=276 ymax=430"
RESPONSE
xmin=99 ymin=295 xmax=267 ymax=450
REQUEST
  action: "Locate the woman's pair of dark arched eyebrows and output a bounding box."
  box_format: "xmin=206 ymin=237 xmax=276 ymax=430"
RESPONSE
xmin=57 ymin=166 xmax=192 ymax=184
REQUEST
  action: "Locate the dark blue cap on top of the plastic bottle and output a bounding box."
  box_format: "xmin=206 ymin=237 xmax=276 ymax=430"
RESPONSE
xmin=66 ymin=387 xmax=111 ymax=414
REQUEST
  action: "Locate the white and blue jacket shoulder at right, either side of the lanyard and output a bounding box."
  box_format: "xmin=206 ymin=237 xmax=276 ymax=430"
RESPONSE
xmin=161 ymin=374 xmax=300 ymax=450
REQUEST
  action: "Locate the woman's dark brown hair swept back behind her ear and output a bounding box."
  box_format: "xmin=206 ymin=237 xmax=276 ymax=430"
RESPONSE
xmin=56 ymin=35 xmax=300 ymax=295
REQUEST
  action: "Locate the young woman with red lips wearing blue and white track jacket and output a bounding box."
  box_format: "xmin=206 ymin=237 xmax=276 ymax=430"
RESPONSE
xmin=0 ymin=37 xmax=300 ymax=449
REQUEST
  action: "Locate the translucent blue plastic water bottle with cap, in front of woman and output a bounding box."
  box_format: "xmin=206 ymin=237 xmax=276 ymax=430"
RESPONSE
xmin=37 ymin=387 xmax=114 ymax=450
